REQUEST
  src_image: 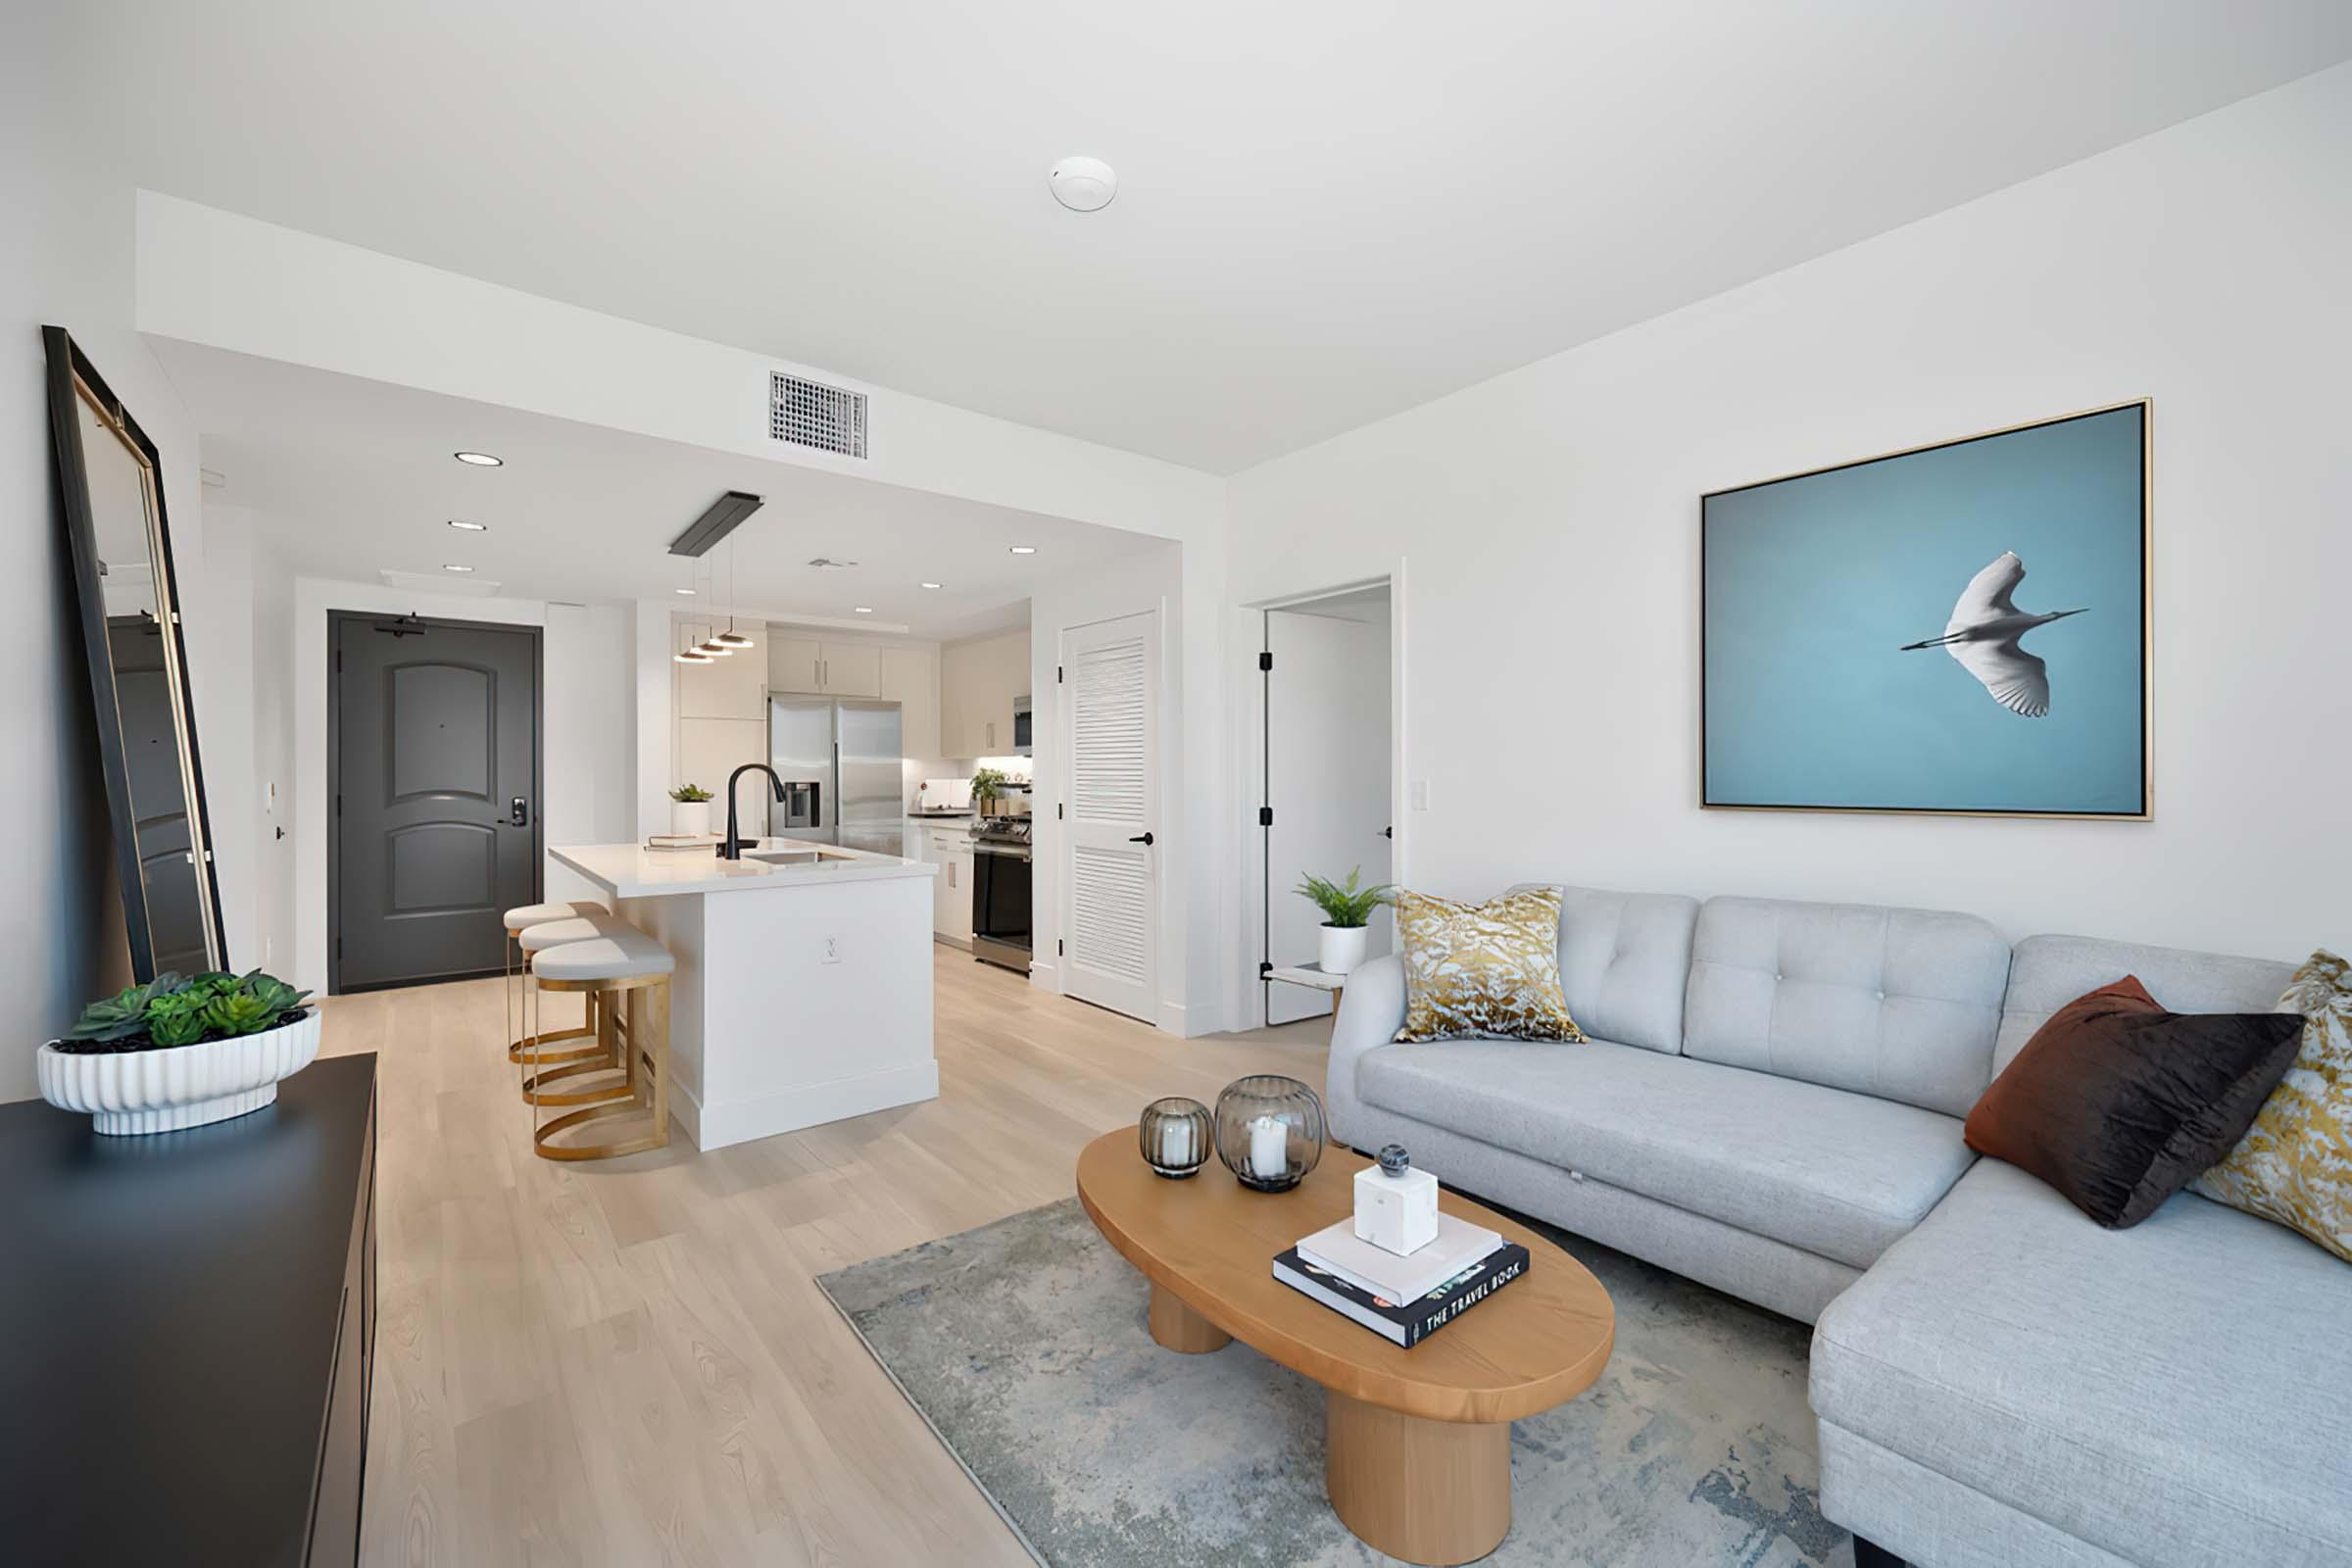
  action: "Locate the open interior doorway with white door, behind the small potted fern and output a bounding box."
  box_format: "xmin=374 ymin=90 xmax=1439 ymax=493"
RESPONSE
xmin=1258 ymin=581 xmax=1395 ymax=1025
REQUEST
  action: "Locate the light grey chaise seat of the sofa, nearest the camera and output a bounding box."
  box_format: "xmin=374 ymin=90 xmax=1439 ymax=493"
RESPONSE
xmin=1811 ymin=1159 xmax=2352 ymax=1568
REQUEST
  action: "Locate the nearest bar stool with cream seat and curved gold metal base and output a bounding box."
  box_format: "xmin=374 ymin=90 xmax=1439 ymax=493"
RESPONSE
xmin=531 ymin=924 xmax=677 ymax=1159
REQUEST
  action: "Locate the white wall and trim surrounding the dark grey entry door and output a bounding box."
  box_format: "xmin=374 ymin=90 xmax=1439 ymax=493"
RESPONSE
xmin=287 ymin=578 xmax=639 ymax=990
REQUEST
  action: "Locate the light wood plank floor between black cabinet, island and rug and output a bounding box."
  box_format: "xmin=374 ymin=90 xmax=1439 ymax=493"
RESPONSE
xmin=324 ymin=948 xmax=1329 ymax=1568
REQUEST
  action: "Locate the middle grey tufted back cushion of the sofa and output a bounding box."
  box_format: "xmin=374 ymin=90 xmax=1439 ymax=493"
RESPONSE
xmin=1682 ymin=898 xmax=2009 ymax=1116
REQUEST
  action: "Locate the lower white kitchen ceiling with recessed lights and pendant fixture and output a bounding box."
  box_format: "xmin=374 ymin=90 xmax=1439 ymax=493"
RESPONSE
xmin=153 ymin=338 xmax=1169 ymax=639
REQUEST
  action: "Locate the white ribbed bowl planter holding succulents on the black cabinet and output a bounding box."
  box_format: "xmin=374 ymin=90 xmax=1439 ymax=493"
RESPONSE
xmin=35 ymin=1006 xmax=318 ymax=1133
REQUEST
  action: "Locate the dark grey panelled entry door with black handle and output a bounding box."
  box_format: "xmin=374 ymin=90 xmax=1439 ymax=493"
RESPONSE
xmin=329 ymin=613 xmax=539 ymax=992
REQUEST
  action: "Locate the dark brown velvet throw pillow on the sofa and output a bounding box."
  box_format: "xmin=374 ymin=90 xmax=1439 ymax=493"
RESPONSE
xmin=1966 ymin=976 xmax=2303 ymax=1230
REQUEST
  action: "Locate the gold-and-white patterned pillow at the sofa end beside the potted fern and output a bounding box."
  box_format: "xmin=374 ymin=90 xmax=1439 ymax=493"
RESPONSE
xmin=1397 ymin=889 xmax=1586 ymax=1042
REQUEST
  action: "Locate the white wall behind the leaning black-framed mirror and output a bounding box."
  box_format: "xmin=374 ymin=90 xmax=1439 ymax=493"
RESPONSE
xmin=0 ymin=7 xmax=227 ymax=1101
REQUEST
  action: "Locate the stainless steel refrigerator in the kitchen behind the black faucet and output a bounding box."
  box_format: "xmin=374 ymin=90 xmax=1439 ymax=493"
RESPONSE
xmin=766 ymin=696 xmax=906 ymax=856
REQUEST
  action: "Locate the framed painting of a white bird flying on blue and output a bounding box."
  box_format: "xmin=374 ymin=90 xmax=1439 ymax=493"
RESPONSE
xmin=1698 ymin=400 xmax=2150 ymax=820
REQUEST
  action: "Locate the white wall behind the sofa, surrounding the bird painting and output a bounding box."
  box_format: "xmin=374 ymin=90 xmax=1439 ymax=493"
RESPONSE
xmin=1230 ymin=66 xmax=2352 ymax=959
